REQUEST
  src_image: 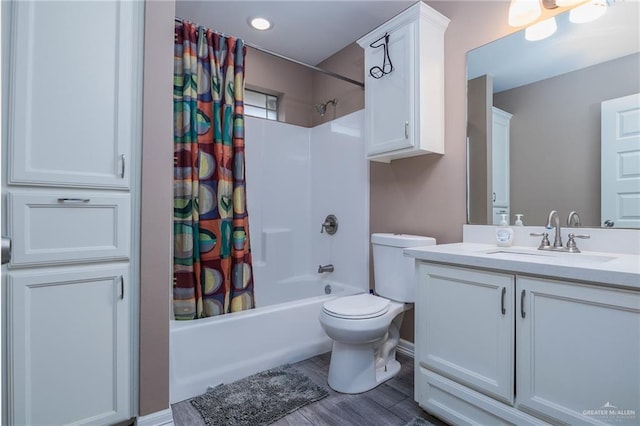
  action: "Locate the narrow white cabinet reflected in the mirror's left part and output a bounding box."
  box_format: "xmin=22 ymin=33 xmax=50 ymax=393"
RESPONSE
xmin=491 ymin=107 xmax=511 ymax=225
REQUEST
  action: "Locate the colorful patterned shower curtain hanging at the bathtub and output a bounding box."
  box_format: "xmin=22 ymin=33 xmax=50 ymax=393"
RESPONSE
xmin=173 ymin=21 xmax=254 ymax=319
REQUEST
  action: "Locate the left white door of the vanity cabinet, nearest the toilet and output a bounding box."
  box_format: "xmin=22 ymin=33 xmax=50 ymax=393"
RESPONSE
xmin=415 ymin=263 xmax=514 ymax=404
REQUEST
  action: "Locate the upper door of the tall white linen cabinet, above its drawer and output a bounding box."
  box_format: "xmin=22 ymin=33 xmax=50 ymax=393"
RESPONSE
xmin=8 ymin=1 xmax=139 ymax=188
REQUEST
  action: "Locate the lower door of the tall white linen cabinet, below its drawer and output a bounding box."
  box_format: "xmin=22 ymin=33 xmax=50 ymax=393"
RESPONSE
xmin=7 ymin=264 xmax=131 ymax=425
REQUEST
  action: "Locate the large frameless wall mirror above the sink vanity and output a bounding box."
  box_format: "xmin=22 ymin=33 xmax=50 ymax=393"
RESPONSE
xmin=467 ymin=2 xmax=640 ymax=228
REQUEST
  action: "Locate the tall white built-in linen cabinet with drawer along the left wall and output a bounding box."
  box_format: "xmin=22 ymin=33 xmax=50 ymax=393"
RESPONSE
xmin=2 ymin=0 xmax=144 ymax=425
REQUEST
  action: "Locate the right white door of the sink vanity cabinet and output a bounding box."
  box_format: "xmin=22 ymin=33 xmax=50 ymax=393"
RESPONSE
xmin=516 ymin=276 xmax=640 ymax=424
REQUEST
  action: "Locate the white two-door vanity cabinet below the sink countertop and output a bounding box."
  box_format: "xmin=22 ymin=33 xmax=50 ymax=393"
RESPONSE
xmin=415 ymin=262 xmax=640 ymax=425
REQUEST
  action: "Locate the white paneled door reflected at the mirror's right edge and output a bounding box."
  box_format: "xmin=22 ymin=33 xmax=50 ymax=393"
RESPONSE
xmin=600 ymin=93 xmax=640 ymax=228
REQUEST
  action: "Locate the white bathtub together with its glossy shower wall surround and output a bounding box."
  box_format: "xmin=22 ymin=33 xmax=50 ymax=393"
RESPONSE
xmin=170 ymin=111 xmax=369 ymax=403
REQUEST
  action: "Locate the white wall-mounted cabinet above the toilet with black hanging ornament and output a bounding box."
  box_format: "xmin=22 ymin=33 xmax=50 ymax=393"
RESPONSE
xmin=358 ymin=2 xmax=449 ymax=162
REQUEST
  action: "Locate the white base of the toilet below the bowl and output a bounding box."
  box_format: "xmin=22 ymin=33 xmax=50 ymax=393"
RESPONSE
xmin=328 ymin=342 xmax=400 ymax=394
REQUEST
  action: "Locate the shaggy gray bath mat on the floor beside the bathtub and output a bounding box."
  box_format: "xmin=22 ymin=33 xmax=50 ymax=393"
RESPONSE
xmin=191 ymin=365 xmax=329 ymax=426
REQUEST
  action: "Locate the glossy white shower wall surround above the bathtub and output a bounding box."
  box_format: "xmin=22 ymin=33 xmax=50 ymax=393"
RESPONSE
xmin=246 ymin=111 xmax=369 ymax=292
